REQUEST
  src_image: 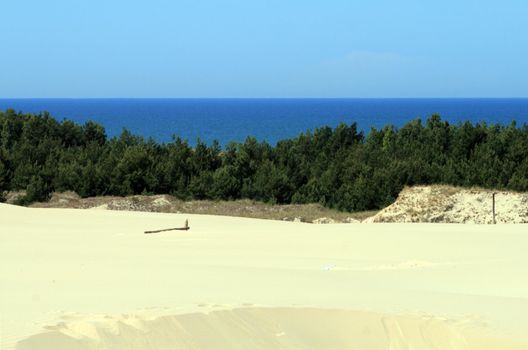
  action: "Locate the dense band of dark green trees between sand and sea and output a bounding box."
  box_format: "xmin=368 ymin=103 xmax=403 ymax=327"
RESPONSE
xmin=0 ymin=110 xmax=528 ymax=211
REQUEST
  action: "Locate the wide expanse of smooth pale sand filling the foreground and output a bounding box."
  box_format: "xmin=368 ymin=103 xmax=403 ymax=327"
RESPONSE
xmin=0 ymin=205 xmax=528 ymax=350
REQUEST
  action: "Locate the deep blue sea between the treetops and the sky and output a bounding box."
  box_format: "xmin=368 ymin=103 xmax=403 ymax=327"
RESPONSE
xmin=0 ymin=98 xmax=528 ymax=145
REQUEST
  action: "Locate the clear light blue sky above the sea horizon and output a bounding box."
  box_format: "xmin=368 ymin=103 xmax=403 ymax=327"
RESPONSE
xmin=0 ymin=0 xmax=528 ymax=97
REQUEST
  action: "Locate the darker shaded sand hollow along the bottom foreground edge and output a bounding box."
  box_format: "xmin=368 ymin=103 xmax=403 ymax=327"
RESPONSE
xmin=17 ymin=308 xmax=523 ymax=350
